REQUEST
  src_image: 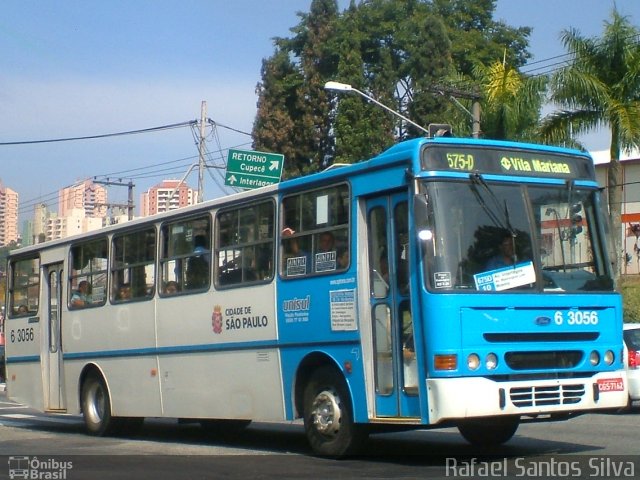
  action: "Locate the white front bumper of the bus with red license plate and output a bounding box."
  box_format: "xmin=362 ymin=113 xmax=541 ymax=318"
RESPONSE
xmin=427 ymin=370 xmax=628 ymax=424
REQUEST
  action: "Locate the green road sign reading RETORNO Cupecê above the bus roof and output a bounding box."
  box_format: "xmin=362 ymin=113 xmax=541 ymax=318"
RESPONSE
xmin=224 ymin=149 xmax=284 ymax=188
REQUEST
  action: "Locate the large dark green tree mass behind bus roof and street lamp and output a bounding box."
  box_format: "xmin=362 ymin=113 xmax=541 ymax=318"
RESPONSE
xmin=253 ymin=0 xmax=537 ymax=177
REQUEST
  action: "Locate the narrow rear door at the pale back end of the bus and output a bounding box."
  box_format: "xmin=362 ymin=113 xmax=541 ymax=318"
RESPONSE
xmin=42 ymin=263 xmax=66 ymax=410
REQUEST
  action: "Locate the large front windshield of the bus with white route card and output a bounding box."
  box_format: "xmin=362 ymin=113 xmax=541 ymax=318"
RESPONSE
xmin=416 ymin=180 xmax=613 ymax=292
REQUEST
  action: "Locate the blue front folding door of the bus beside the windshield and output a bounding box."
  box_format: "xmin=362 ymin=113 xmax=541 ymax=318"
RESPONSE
xmin=367 ymin=192 xmax=420 ymax=417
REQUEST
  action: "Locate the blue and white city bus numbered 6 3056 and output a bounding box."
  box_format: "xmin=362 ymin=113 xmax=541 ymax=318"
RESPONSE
xmin=6 ymin=138 xmax=627 ymax=456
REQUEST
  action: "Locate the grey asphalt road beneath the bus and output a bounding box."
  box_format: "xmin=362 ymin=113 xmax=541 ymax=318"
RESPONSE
xmin=0 ymin=393 xmax=640 ymax=480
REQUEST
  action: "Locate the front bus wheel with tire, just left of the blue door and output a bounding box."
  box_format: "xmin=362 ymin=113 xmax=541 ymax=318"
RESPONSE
xmin=303 ymin=367 xmax=367 ymax=457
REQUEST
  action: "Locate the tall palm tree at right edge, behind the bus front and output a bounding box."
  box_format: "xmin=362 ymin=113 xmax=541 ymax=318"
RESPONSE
xmin=541 ymin=8 xmax=640 ymax=279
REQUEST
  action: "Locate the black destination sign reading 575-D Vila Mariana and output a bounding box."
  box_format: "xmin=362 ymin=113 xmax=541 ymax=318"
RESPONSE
xmin=422 ymin=144 xmax=593 ymax=179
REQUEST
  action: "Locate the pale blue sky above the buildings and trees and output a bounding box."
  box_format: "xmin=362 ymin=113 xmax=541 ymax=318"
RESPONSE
xmin=0 ymin=0 xmax=640 ymax=221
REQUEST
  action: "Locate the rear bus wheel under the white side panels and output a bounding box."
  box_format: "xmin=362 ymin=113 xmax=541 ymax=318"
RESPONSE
xmin=81 ymin=373 xmax=117 ymax=436
